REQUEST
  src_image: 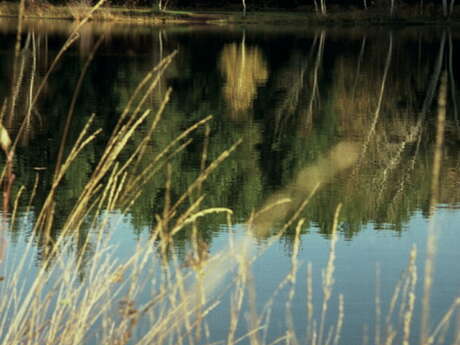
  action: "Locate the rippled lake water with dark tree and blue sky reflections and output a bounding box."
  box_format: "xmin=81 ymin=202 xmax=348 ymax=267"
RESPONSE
xmin=0 ymin=20 xmax=460 ymax=344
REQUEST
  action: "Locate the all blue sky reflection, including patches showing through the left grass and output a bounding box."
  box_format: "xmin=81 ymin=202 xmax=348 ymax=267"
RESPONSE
xmin=0 ymin=208 xmax=460 ymax=344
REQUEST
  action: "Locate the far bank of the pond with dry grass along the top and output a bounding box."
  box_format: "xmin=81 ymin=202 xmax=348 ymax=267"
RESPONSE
xmin=0 ymin=2 xmax=460 ymax=26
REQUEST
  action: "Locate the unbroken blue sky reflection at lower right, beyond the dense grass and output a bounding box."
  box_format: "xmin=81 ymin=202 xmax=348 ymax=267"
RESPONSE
xmin=211 ymin=209 xmax=460 ymax=344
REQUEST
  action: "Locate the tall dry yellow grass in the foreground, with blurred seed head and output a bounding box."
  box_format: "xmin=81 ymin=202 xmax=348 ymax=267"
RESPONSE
xmin=0 ymin=4 xmax=460 ymax=345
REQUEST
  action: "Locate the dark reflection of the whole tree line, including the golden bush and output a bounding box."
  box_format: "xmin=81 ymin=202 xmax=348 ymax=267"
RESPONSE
xmin=0 ymin=24 xmax=460 ymax=264
